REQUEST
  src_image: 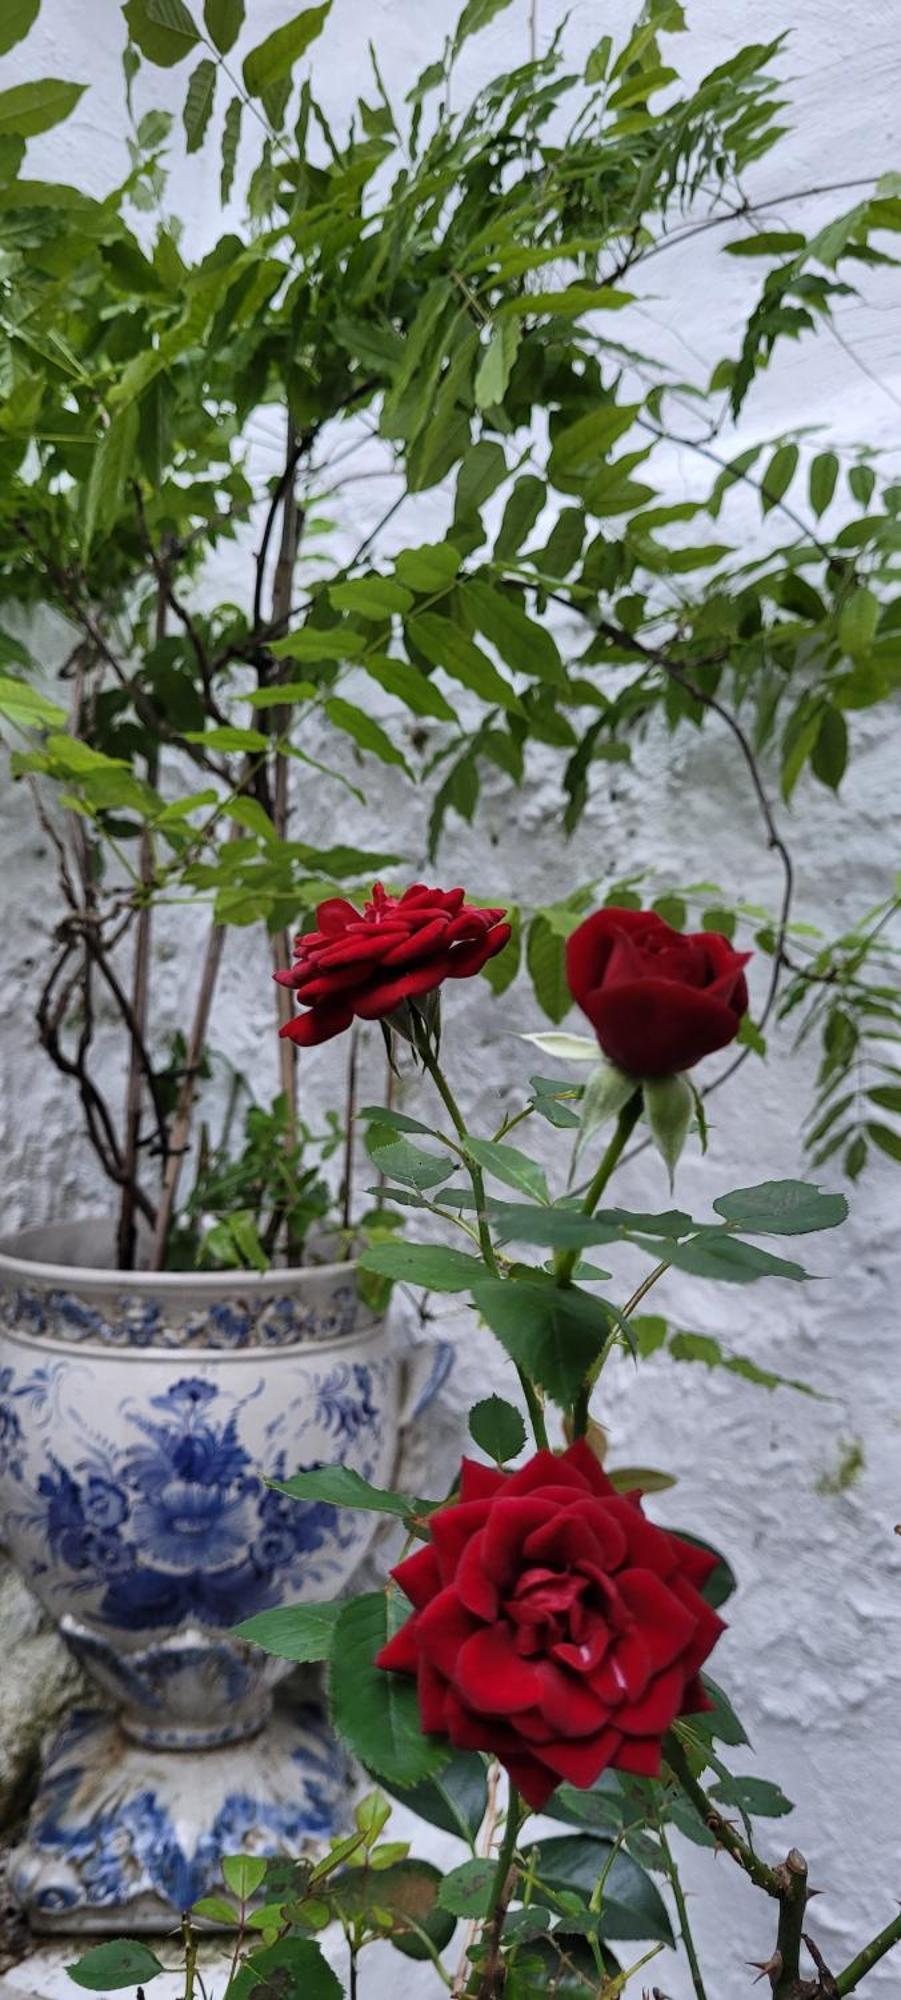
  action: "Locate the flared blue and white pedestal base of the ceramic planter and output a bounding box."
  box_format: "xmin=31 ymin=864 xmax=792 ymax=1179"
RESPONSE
xmin=10 ymin=1700 xmax=350 ymax=1936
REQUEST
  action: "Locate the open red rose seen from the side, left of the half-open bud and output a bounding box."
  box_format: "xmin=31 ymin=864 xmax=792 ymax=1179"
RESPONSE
xmin=276 ymin=882 xmax=511 ymax=1048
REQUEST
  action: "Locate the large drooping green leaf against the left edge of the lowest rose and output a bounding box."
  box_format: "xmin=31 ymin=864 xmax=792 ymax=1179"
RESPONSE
xmin=328 ymin=1586 xmax=448 ymax=1786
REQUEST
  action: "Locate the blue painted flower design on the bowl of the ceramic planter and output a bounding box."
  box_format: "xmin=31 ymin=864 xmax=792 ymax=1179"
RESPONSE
xmin=0 ymin=1362 xmax=384 ymax=1632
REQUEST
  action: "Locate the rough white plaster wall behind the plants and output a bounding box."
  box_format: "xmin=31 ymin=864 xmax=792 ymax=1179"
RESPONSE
xmin=0 ymin=0 xmax=901 ymax=2000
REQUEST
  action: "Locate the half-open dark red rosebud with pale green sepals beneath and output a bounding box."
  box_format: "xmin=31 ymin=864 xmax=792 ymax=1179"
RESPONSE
xmin=567 ymin=910 xmax=751 ymax=1076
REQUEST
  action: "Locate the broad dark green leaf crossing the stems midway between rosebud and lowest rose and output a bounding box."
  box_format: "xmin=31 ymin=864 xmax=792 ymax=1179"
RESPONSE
xmin=473 ymin=1278 xmax=611 ymax=1408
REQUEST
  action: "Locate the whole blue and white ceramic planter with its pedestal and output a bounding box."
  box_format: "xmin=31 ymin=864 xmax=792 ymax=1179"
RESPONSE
xmin=0 ymin=1224 xmax=446 ymax=1930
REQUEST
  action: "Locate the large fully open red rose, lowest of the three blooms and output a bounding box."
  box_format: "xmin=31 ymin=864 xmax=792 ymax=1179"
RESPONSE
xmin=376 ymin=1440 xmax=725 ymax=1810
